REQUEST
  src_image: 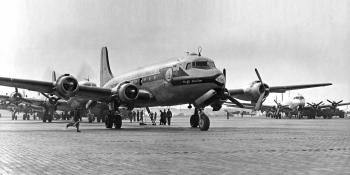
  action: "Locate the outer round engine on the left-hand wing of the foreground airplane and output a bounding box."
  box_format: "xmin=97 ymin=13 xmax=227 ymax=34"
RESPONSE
xmin=56 ymin=74 xmax=79 ymax=99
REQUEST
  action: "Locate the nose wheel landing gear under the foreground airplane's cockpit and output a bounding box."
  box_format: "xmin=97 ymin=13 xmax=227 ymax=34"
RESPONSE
xmin=190 ymin=108 xmax=210 ymax=131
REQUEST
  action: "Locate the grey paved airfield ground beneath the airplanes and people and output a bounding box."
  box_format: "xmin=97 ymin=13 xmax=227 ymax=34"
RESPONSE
xmin=0 ymin=116 xmax=350 ymax=175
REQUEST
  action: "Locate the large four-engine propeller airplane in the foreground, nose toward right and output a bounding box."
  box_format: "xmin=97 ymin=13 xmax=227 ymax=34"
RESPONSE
xmin=0 ymin=47 xmax=331 ymax=131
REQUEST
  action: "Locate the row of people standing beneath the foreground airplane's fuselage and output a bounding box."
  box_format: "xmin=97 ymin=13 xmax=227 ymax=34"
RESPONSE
xmin=129 ymin=109 xmax=173 ymax=125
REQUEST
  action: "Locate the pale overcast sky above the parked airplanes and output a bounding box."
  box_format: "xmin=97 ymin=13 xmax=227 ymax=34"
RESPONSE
xmin=0 ymin=0 xmax=350 ymax=106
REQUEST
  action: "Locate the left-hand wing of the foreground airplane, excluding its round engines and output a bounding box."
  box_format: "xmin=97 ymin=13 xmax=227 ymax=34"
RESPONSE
xmin=0 ymin=77 xmax=112 ymax=100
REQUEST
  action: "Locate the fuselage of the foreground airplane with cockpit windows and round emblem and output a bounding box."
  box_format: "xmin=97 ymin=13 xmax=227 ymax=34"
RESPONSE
xmin=104 ymin=54 xmax=224 ymax=107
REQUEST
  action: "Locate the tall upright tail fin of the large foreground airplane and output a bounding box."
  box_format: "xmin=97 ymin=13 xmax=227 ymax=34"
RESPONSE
xmin=100 ymin=47 xmax=113 ymax=87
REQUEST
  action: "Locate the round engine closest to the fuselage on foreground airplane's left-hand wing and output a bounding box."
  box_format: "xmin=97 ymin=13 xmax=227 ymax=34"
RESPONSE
xmin=112 ymin=82 xmax=139 ymax=103
